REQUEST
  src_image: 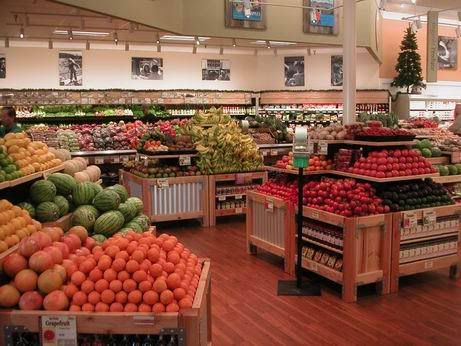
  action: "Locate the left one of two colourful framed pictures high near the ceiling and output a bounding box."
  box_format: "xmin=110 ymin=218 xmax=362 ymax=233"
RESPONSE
xmin=224 ymin=0 xmax=266 ymax=30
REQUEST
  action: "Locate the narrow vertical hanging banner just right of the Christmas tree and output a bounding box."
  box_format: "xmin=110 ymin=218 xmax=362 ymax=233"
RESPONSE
xmin=426 ymin=11 xmax=439 ymax=83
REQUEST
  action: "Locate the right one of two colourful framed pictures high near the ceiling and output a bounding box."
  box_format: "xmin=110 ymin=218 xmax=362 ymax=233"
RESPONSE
xmin=303 ymin=0 xmax=339 ymax=35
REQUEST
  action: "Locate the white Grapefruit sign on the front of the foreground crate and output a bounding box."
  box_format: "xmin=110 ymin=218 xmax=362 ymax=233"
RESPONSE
xmin=40 ymin=316 xmax=77 ymax=346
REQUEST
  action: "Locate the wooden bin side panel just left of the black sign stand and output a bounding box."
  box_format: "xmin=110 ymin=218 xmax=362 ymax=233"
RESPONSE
xmin=246 ymin=191 xmax=295 ymax=275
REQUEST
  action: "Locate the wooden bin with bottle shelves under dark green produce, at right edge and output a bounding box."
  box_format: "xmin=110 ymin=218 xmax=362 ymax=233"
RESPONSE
xmin=391 ymin=204 xmax=461 ymax=293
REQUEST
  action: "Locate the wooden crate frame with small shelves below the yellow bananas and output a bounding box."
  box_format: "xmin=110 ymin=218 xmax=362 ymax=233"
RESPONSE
xmin=208 ymin=172 xmax=267 ymax=226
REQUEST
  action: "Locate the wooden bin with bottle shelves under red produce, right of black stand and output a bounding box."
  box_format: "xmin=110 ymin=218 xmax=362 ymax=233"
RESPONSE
xmin=300 ymin=207 xmax=392 ymax=302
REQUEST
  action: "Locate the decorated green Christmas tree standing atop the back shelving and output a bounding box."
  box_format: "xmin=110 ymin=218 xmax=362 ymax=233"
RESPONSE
xmin=391 ymin=27 xmax=426 ymax=93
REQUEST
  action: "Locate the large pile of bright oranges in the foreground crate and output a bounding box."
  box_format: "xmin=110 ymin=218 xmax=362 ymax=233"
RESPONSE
xmin=63 ymin=232 xmax=201 ymax=313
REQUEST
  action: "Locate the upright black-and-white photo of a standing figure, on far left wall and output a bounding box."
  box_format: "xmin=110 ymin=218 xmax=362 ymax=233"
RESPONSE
xmin=59 ymin=51 xmax=83 ymax=86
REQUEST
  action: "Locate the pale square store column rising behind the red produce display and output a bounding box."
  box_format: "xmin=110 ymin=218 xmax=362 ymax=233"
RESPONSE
xmin=343 ymin=0 xmax=357 ymax=124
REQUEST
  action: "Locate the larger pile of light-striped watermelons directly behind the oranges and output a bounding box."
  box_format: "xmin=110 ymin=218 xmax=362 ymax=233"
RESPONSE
xmin=71 ymin=182 xmax=150 ymax=243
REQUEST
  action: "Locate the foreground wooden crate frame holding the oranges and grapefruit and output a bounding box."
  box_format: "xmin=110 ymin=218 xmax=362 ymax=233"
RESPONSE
xmin=0 ymin=260 xmax=211 ymax=346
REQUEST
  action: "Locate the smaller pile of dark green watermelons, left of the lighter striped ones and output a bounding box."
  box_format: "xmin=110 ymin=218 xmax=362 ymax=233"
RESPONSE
xmin=19 ymin=173 xmax=77 ymax=222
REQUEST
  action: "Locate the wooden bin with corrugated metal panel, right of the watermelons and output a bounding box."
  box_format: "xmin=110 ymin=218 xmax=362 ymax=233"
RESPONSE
xmin=120 ymin=170 xmax=209 ymax=227
